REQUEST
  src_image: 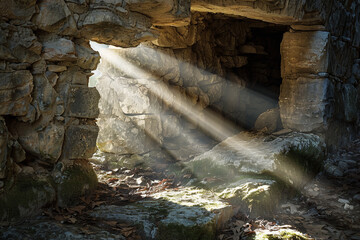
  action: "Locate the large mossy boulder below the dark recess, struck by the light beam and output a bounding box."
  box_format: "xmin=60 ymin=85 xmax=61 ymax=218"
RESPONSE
xmin=187 ymin=132 xmax=325 ymax=186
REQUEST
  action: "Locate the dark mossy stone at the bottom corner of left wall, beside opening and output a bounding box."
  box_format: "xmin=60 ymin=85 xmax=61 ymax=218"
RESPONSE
xmin=52 ymin=160 xmax=98 ymax=207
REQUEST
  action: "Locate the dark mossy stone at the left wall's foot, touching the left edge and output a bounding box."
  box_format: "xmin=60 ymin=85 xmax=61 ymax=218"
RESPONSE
xmin=0 ymin=174 xmax=55 ymax=221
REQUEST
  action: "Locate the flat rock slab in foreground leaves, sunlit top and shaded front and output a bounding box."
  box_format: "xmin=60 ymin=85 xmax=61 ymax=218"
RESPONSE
xmin=91 ymin=188 xmax=233 ymax=240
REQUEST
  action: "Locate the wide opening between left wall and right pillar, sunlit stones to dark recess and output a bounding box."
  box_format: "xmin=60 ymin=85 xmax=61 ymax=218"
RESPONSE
xmin=90 ymin=13 xmax=288 ymax=163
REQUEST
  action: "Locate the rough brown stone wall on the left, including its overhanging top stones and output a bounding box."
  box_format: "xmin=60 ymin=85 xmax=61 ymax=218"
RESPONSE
xmin=0 ymin=0 xmax=190 ymax=221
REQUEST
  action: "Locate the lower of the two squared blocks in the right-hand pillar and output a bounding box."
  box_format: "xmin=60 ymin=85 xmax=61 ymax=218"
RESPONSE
xmin=279 ymin=77 xmax=334 ymax=132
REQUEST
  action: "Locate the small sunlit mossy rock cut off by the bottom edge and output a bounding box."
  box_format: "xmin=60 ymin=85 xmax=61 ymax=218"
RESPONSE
xmin=254 ymin=229 xmax=313 ymax=240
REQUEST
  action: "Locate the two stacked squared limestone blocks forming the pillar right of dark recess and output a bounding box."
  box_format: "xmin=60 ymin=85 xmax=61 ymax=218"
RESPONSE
xmin=279 ymin=31 xmax=334 ymax=132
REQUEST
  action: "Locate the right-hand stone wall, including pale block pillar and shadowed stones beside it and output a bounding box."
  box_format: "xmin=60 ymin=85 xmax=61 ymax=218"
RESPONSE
xmin=280 ymin=1 xmax=360 ymax=149
